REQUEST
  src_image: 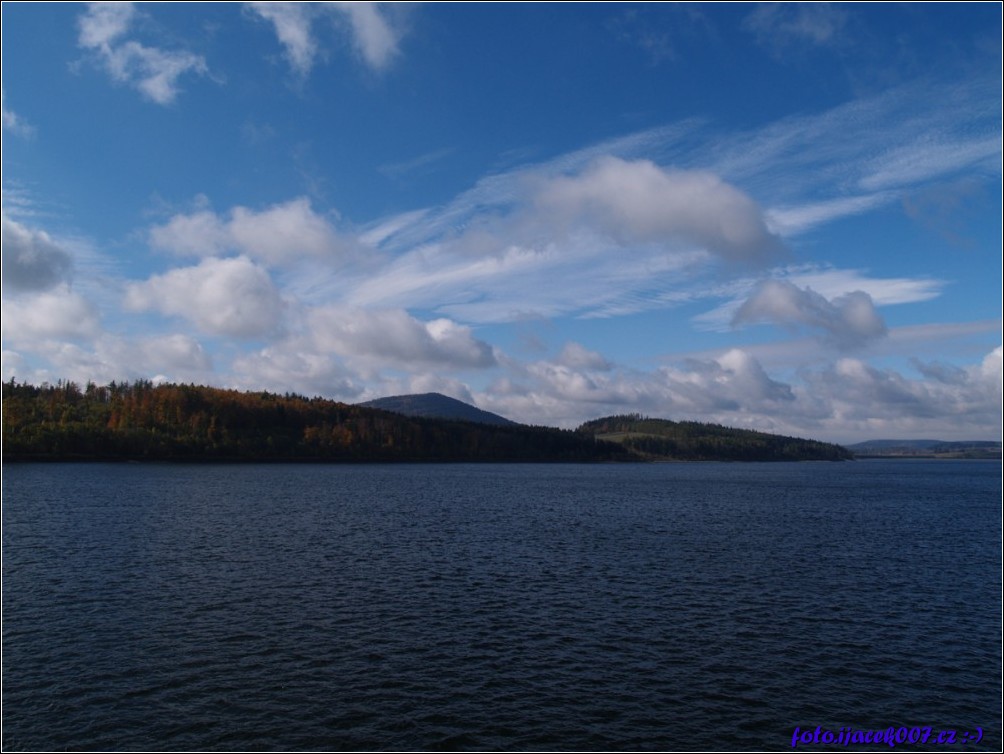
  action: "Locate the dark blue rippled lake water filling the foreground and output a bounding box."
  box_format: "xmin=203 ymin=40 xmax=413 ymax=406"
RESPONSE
xmin=2 ymin=461 xmax=1001 ymax=751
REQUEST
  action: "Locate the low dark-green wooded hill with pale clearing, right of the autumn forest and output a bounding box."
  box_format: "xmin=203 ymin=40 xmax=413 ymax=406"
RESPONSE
xmin=576 ymin=414 xmax=853 ymax=461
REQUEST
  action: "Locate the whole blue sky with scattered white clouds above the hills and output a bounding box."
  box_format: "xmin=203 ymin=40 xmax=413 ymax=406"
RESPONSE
xmin=2 ymin=2 xmax=1002 ymax=443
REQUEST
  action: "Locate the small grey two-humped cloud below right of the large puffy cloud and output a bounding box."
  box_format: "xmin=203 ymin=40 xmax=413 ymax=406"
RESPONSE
xmin=732 ymin=280 xmax=887 ymax=347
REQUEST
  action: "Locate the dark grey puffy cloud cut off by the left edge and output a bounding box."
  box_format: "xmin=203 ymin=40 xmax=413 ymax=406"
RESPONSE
xmin=0 ymin=214 xmax=73 ymax=291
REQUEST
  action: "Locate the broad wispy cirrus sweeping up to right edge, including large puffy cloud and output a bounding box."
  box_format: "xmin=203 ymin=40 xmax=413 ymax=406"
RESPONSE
xmin=301 ymin=72 xmax=1000 ymax=328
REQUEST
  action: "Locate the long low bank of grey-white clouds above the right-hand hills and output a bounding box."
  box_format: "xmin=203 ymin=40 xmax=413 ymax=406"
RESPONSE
xmin=474 ymin=347 xmax=1002 ymax=442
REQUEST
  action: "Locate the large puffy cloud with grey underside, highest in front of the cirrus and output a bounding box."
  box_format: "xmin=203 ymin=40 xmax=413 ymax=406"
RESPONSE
xmin=536 ymin=157 xmax=781 ymax=262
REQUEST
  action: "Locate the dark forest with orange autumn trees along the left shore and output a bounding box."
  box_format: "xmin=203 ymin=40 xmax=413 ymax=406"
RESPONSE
xmin=3 ymin=380 xmax=632 ymax=462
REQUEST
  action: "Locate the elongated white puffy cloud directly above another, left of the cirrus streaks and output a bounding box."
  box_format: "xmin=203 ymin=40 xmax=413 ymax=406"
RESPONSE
xmin=150 ymin=197 xmax=350 ymax=265
